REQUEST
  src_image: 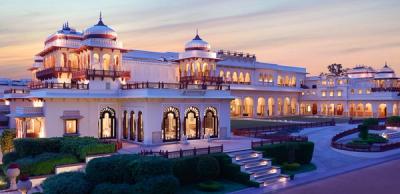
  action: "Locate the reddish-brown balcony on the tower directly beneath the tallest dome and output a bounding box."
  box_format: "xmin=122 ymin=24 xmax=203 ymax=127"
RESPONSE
xmin=72 ymin=69 xmax=131 ymax=80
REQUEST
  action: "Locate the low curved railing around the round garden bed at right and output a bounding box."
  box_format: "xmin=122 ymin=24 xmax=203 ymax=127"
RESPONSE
xmin=331 ymin=125 xmax=400 ymax=152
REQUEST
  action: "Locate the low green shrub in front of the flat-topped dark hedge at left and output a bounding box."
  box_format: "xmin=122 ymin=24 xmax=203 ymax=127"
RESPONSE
xmin=15 ymin=153 xmax=79 ymax=176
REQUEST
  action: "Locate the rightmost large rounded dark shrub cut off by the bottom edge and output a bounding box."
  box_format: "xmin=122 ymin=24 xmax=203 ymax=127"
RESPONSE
xmin=133 ymin=172 xmax=179 ymax=194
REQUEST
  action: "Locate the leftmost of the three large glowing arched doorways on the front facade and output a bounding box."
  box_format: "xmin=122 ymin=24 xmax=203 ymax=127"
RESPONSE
xmin=162 ymin=107 xmax=180 ymax=142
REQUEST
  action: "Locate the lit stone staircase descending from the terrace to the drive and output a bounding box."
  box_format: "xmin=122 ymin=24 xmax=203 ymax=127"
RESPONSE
xmin=228 ymin=150 xmax=289 ymax=187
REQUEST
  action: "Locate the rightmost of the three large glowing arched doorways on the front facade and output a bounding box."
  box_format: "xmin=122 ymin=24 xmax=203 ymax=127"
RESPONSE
xmin=203 ymin=107 xmax=218 ymax=138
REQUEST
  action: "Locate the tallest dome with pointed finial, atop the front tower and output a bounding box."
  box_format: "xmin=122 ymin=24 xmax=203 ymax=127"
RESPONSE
xmin=83 ymin=14 xmax=117 ymax=40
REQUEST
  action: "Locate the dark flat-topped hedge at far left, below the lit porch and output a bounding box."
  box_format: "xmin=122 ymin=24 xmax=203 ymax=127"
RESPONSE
xmin=14 ymin=138 xmax=62 ymax=157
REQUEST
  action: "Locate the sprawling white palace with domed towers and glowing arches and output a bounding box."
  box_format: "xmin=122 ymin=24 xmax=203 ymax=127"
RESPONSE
xmin=3 ymin=16 xmax=399 ymax=145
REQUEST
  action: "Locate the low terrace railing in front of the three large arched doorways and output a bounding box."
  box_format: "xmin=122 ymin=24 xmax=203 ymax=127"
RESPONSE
xmin=140 ymin=144 xmax=224 ymax=159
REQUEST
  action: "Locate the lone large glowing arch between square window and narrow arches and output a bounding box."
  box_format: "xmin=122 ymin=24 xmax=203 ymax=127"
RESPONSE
xmin=99 ymin=107 xmax=117 ymax=139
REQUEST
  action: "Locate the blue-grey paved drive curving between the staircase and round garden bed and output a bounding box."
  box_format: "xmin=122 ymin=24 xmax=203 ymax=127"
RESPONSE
xmin=235 ymin=124 xmax=400 ymax=194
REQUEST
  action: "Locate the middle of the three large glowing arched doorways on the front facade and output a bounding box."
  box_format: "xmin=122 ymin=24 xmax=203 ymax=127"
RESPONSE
xmin=183 ymin=106 xmax=200 ymax=139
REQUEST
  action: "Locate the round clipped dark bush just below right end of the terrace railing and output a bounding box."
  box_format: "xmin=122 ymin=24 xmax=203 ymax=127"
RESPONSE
xmin=197 ymin=156 xmax=220 ymax=180
